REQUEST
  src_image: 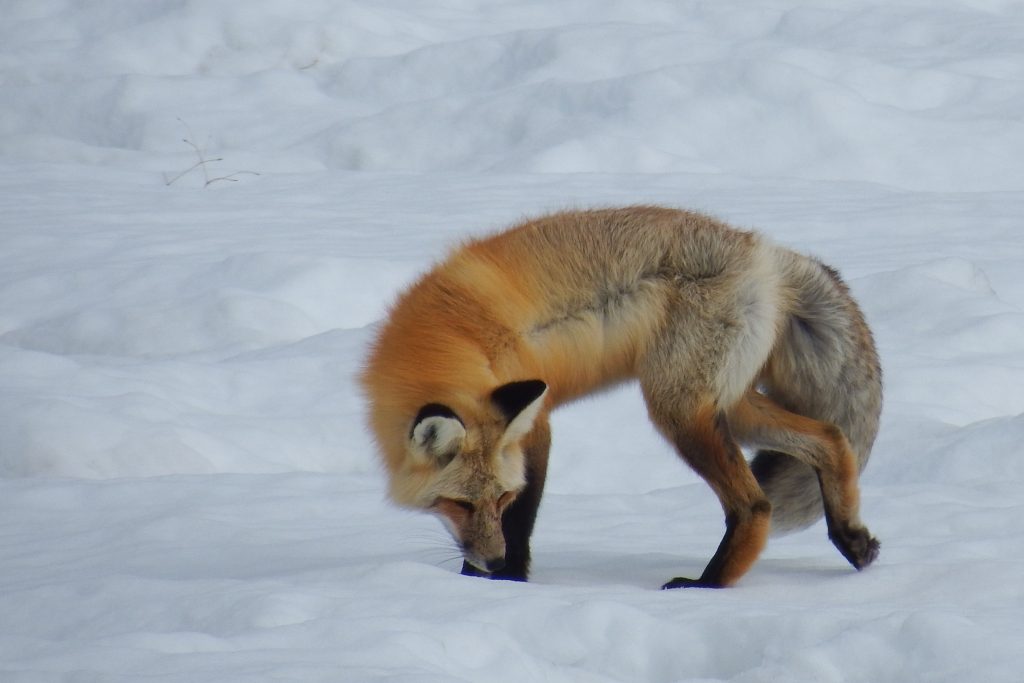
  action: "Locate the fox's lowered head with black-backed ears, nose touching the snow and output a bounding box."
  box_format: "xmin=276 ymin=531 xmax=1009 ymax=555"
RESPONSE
xmin=405 ymin=380 xmax=547 ymax=572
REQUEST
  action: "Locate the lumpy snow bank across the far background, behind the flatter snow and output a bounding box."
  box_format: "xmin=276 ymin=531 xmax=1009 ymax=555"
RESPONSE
xmin=0 ymin=0 xmax=1024 ymax=190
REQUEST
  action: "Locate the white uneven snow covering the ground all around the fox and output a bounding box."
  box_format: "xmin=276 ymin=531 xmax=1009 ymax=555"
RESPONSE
xmin=0 ymin=0 xmax=1024 ymax=683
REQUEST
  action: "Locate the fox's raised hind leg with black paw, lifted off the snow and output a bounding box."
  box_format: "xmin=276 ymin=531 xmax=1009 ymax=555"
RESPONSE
xmin=729 ymin=391 xmax=880 ymax=569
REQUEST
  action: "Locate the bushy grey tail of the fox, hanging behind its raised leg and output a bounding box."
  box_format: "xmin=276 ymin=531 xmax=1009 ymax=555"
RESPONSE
xmin=751 ymin=254 xmax=882 ymax=533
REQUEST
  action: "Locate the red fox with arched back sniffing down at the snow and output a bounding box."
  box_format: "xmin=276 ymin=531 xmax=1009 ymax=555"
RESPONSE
xmin=361 ymin=207 xmax=882 ymax=588
